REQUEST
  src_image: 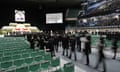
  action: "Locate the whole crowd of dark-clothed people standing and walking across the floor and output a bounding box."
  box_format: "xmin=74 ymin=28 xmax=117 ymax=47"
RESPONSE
xmin=27 ymin=31 xmax=120 ymax=72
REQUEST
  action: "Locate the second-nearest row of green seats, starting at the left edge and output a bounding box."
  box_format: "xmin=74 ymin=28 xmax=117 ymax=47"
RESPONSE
xmin=0 ymin=53 xmax=52 ymax=70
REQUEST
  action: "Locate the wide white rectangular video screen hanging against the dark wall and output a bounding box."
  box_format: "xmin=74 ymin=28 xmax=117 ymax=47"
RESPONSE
xmin=46 ymin=13 xmax=63 ymax=24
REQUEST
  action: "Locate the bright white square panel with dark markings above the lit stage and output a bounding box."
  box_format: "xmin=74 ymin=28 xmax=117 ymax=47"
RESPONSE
xmin=15 ymin=10 xmax=25 ymax=22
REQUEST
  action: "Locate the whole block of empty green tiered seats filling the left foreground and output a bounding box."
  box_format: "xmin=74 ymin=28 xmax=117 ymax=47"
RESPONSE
xmin=0 ymin=38 xmax=74 ymax=72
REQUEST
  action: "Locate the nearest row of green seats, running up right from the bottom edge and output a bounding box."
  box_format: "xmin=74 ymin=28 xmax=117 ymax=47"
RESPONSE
xmin=7 ymin=58 xmax=60 ymax=72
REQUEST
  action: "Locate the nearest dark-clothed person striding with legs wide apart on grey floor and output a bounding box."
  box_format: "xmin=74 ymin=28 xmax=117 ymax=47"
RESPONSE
xmin=95 ymin=37 xmax=106 ymax=72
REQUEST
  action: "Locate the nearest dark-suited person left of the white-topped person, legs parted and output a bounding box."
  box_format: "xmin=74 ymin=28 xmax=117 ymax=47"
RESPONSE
xmin=69 ymin=35 xmax=77 ymax=61
